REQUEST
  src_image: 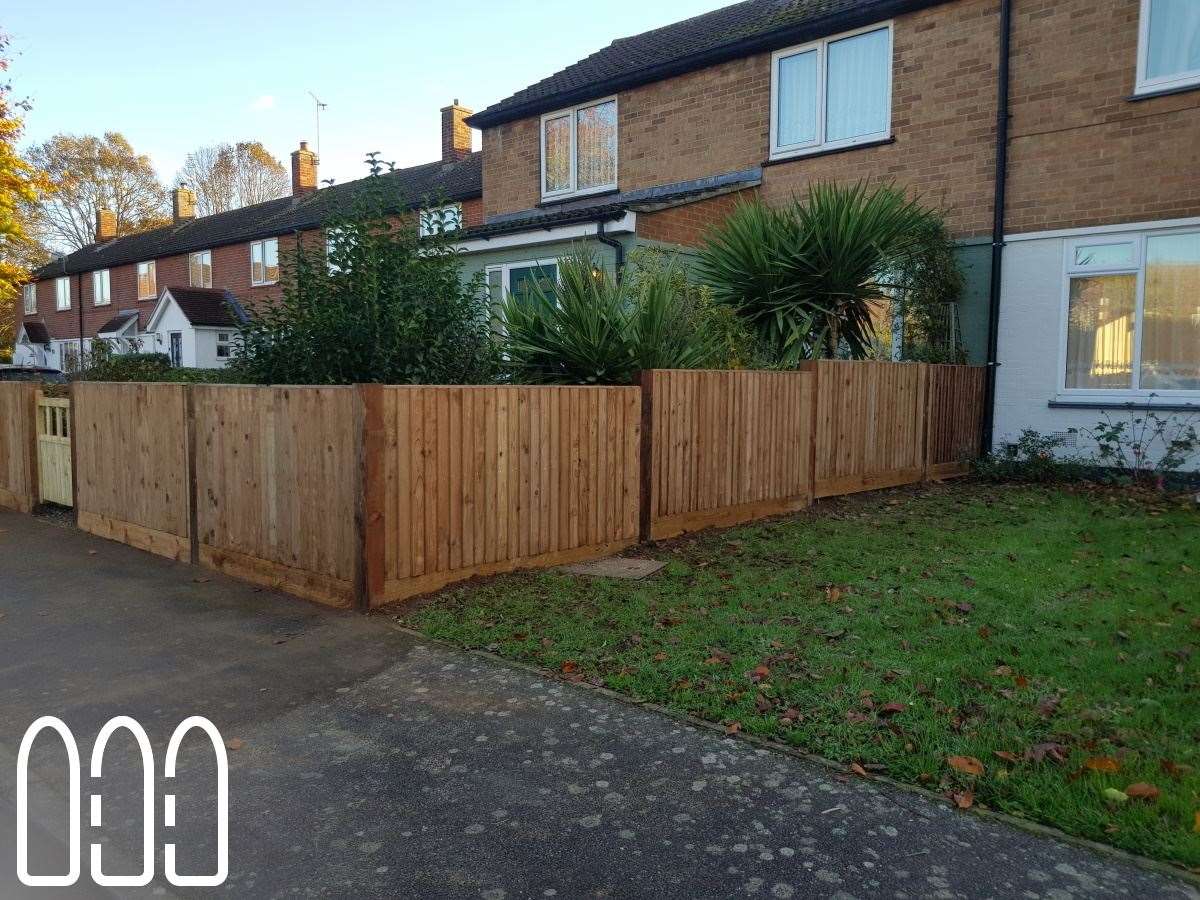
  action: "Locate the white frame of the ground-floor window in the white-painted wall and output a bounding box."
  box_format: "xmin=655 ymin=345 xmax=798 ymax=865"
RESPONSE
xmin=1055 ymin=224 xmax=1200 ymax=403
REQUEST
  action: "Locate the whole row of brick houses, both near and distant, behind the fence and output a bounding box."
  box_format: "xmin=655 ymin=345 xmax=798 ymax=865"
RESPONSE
xmin=11 ymin=0 xmax=1200 ymax=451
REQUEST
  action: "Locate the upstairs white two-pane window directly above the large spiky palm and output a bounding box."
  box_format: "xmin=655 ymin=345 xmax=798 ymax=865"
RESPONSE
xmin=770 ymin=22 xmax=892 ymax=160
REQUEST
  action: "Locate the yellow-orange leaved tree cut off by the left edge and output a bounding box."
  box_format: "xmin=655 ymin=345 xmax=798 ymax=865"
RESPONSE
xmin=0 ymin=31 xmax=50 ymax=356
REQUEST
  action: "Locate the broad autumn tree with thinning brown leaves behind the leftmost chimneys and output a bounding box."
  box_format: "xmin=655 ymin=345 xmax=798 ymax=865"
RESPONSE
xmin=28 ymin=131 xmax=170 ymax=250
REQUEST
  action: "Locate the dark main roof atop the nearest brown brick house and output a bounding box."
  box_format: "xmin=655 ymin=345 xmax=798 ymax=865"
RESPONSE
xmin=467 ymin=0 xmax=948 ymax=128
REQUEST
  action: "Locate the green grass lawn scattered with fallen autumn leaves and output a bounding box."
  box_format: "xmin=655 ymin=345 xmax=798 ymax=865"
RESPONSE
xmin=404 ymin=484 xmax=1200 ymax=868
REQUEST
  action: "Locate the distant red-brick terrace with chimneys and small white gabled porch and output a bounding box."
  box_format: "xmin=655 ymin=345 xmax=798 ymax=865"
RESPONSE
xmin=16 ymin=101 xmax=482 ymax=367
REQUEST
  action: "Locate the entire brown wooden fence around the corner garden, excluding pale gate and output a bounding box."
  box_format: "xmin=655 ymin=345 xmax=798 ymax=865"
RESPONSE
xmin=0 ymin=361 xmax=983 ymax=610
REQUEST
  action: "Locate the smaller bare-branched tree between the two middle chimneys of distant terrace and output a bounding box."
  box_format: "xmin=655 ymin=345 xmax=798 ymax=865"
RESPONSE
xmin=176 ymin=140 xmax=292 ymax=216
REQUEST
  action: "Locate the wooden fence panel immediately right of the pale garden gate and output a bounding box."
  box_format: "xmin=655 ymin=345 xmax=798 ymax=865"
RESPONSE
xmin=72 ymin=382 xmax=192 ymax=562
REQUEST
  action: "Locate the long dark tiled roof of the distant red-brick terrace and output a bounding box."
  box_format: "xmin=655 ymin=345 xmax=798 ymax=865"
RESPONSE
xmin=35 ymin=154 xmax=484 ymax=278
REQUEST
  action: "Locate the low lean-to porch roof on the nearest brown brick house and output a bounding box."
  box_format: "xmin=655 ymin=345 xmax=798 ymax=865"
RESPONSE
xmin=462 ymin=168 xmax=762 ymax=240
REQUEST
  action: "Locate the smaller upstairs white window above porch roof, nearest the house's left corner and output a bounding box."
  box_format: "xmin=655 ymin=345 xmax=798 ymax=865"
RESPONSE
xmin=541 ymin=97 xmax=618 ymax=199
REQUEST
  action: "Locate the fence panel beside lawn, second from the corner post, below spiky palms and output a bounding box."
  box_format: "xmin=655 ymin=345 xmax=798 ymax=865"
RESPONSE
xmin=642 ymin=370 xmax=815 ymax=540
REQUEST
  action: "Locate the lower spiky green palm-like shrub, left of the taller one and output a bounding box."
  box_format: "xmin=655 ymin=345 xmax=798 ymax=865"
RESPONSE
xmin=500 ymin=252 xmax=720 ymax=384
